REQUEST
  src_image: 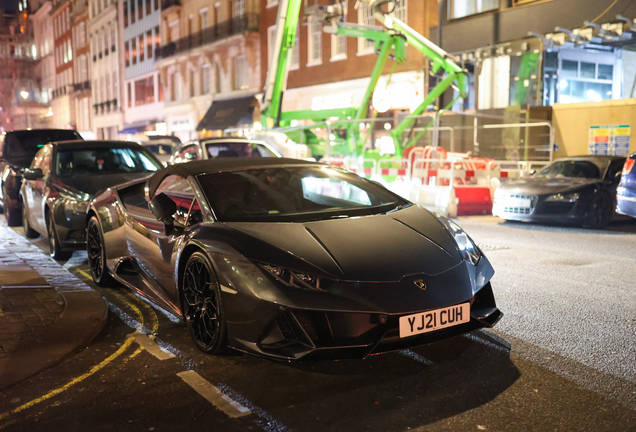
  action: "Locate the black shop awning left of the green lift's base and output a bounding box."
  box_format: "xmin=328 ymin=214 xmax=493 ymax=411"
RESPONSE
xmin=197 ymin=96 xmax=256 ymax=130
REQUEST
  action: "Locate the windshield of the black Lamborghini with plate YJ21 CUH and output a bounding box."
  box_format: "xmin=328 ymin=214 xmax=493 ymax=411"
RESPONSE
xmin=198 ymin=166 xmax=409 ymax=222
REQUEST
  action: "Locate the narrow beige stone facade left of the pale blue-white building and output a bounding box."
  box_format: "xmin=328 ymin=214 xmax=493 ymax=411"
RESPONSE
xmin=88 ymin=0 xmax=124 ymax=139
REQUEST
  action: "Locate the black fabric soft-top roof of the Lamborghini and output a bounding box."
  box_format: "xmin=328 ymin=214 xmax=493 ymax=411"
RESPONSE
xmin=148 ymin=158 xmax=321 ymax=197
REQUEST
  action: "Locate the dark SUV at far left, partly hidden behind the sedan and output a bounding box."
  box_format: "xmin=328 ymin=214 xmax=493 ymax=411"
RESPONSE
xmin=0 ymin=129 xmax=82 ymax=226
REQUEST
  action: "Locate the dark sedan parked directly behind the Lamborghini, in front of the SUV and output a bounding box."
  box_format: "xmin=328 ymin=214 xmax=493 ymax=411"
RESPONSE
xmin=20 ymin=141 xmax=162 ymax=259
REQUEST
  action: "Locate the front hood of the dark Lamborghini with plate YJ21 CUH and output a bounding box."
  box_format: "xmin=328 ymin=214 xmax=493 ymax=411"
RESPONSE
xmin=226 ymin=206 xmax=462 ymax=281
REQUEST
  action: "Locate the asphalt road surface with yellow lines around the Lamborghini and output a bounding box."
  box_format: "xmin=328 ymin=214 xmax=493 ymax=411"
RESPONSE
xmin=0 ymin=217 xmax=636 ymax=432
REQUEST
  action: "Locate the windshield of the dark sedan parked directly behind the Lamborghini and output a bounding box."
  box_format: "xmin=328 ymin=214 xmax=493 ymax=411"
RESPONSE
xmin=55 ymin=147 xmax=163 ymax=177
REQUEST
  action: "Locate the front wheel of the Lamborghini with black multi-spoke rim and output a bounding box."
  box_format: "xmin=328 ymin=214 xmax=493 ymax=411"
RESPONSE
xmin=180 ymin=252 xmax=227 ymax=354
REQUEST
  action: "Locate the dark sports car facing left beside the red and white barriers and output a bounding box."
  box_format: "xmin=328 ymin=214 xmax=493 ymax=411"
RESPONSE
xmin=492 ymin=156 xmax=625 ymax=228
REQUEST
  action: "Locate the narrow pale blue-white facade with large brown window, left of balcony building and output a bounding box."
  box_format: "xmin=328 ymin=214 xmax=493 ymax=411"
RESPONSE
xmin=119 ymin=0 xmax=165 ymax=141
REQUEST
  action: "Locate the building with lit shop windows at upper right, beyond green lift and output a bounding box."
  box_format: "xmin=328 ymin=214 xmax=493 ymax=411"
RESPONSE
xmin=431 ymin=0 xmax=636 ymax=109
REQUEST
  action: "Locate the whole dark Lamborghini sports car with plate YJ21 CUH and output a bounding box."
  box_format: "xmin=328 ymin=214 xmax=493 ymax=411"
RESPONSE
xmin=87 ymin=158 xmax=502 ymax=361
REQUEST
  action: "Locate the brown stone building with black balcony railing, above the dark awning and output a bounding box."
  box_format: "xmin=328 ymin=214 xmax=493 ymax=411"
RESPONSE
xmin=154 ymin=0 xmax=261 ymax=141
